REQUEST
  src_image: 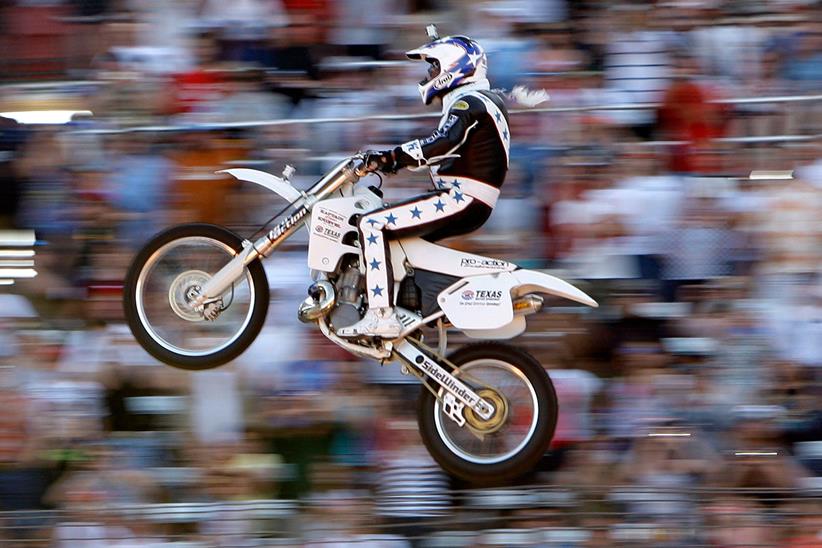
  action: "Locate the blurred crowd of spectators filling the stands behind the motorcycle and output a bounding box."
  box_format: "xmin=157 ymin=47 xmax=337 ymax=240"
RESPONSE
xmin=0 ymin=0 xmax=822 ymax=547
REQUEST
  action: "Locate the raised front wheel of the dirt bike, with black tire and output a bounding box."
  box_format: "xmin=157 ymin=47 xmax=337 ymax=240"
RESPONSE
xmin=123 ymin=224 xmax=268 ymax=371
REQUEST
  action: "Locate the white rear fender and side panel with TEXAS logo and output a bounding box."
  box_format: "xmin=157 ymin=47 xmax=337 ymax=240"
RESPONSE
xmin=437 ymin=270 xmax=598 ymax=339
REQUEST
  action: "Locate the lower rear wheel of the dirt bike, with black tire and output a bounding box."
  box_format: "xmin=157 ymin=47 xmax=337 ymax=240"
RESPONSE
xmin=418 ymin=343 xmax=557 ymax=485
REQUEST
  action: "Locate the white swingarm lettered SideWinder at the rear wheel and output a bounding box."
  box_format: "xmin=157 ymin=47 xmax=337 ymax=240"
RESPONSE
xmin=394 ymin=339 xmax=495 ymax=426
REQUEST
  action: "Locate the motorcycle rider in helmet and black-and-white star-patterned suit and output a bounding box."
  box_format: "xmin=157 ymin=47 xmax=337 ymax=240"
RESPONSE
xmin=337 ymin=36 xmax=511 ymax=339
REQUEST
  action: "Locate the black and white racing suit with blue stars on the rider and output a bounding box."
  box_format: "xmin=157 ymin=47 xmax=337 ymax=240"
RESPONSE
xmin=339 ymin=80 xmax=510 ymax=336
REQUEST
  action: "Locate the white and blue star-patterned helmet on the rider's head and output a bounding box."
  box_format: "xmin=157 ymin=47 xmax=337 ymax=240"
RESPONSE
xmin=405 ymin=36 xmax=488 ymax=105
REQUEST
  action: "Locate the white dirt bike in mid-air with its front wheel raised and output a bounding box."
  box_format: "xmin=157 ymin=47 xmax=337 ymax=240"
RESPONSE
xmin=124 ymin=154 xmax=597 ymax=483
